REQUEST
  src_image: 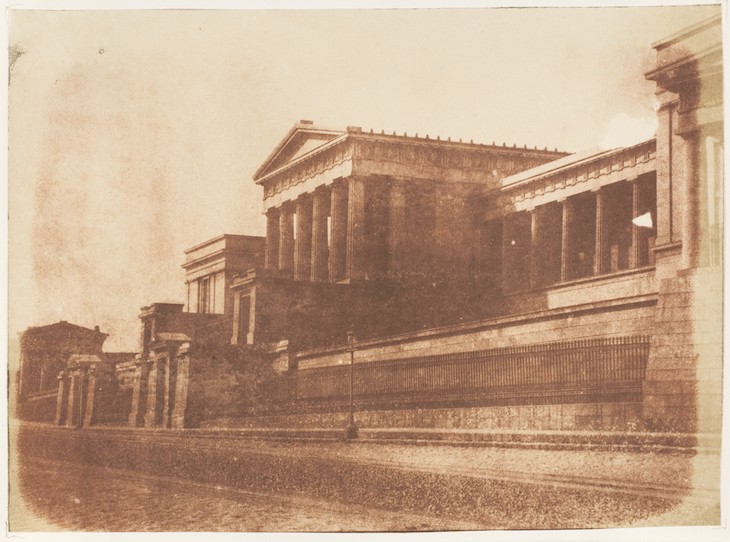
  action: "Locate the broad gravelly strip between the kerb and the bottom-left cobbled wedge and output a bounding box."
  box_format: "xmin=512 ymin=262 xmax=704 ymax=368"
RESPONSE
xmin=8 ymin=426 xmax=720 ymax=531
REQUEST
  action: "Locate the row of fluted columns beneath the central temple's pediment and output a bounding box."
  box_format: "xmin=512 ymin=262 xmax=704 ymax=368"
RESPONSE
xmin=265 ymin=180 xmax=407 ymax=282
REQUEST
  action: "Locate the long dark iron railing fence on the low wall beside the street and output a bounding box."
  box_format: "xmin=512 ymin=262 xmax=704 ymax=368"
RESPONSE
xmin=292 ymin=336 xmax=649 ymax=407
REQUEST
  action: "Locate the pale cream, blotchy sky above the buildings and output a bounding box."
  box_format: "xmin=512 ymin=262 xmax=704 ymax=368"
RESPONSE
xmin=6 ymin=2 xmax=719 ymax=351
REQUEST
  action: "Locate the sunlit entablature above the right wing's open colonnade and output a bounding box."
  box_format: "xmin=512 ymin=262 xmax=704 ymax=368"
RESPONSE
xmin=502 ymin=139 xmax=657 ymax=211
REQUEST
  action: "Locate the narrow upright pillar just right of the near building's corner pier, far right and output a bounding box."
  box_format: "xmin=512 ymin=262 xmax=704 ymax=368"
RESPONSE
xmin=682 ymin=132 xmax=700 ymax=269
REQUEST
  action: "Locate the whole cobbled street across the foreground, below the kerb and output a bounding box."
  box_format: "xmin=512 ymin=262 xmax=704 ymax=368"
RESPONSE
xmin=10 ymin=426 xmax=719 ymax=532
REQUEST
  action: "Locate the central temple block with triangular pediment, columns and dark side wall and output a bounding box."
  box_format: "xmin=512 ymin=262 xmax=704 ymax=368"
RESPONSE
xmin=254 ymin=121 xmax=564 ymax=283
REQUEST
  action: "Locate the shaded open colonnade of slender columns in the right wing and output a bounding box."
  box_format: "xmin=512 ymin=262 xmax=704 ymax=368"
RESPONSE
xmin=502 ymin=174 xmax=656 ymax=292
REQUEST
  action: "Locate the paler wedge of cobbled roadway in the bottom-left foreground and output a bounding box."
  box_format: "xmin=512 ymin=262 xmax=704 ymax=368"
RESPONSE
xmin=10 ymin=459 xmax=480 ymax=531
